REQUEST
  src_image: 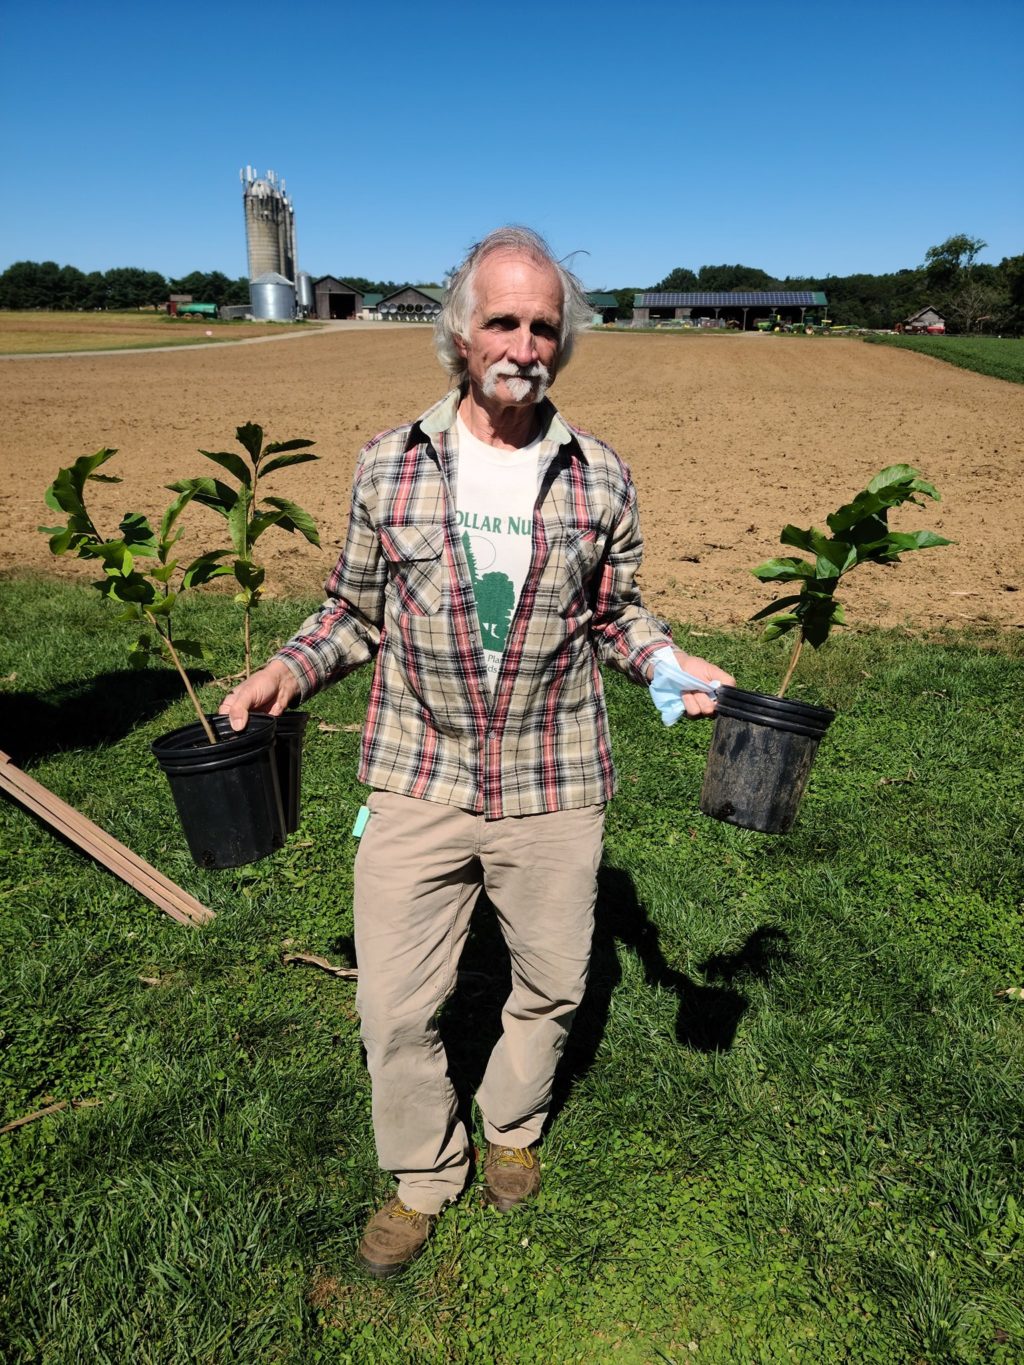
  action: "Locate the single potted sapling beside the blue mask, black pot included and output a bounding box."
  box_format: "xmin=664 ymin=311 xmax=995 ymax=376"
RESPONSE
xmin=700 ymin=464 xmax=950 ymax=834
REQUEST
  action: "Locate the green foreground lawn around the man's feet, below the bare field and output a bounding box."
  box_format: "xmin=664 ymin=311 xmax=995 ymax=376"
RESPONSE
xmin=0 ymin=580 xmax=1024 ymax=1365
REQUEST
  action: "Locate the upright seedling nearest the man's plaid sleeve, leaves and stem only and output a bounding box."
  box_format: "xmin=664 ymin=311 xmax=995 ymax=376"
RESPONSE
xmin=168 ymin=422 xmax=319 ymax=677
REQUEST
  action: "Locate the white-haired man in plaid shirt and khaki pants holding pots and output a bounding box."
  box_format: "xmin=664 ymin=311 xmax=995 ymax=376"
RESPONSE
xmin=221 ymin=228 xmax=732 ymax=1276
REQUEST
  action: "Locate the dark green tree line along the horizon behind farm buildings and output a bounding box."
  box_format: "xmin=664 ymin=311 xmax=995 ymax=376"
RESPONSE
xmin=0 ymin=233 xmax=1024 ymax=336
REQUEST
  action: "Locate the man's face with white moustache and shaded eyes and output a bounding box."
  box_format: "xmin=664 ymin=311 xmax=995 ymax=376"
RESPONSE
xmin=456 ymin=251 xmax=561 ymax=407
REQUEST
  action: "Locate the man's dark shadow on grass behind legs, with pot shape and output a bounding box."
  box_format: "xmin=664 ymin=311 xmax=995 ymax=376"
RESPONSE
xmin=440 ymin=865 xmax=789 ymax=1127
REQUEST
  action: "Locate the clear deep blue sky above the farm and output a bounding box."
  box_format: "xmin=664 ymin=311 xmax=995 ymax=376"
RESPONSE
xmin=0 ymin=0 xmax=1024 ymax=288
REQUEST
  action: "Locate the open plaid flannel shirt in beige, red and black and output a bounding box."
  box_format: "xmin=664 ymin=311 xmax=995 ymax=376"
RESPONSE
xmin=277 ymin=392 xmax=670 ymax=819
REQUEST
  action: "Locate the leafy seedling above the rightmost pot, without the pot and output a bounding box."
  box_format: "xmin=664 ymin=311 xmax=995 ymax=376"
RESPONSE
xmin=751 ymin=464 xmax=953 ymax=696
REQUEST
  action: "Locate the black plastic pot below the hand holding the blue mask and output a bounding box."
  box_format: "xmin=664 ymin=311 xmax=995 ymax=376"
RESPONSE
xmin=700 ymin=687 xmax=836 ymax=834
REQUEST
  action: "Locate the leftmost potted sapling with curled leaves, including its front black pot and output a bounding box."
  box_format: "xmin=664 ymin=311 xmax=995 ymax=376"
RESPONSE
xmin=40 ymin=448 xmax=284 ymax=867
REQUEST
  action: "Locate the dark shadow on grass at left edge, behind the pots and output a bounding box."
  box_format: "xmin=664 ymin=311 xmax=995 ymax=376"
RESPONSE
xmin=0 ymin=669 xmax=213 ymax=767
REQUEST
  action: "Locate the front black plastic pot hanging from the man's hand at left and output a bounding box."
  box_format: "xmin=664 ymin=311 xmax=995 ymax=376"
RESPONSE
xmin=152 ymin=715 xmax=284 ymax=867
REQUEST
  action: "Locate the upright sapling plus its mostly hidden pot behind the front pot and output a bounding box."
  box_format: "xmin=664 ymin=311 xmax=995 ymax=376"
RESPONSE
xmin=168 ymin=422 xmax=319 ymax=834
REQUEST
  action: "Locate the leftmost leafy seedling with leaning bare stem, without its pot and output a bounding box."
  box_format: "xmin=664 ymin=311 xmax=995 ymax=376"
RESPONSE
xmin=40 ymin=446 xmax=231 ymax=744
